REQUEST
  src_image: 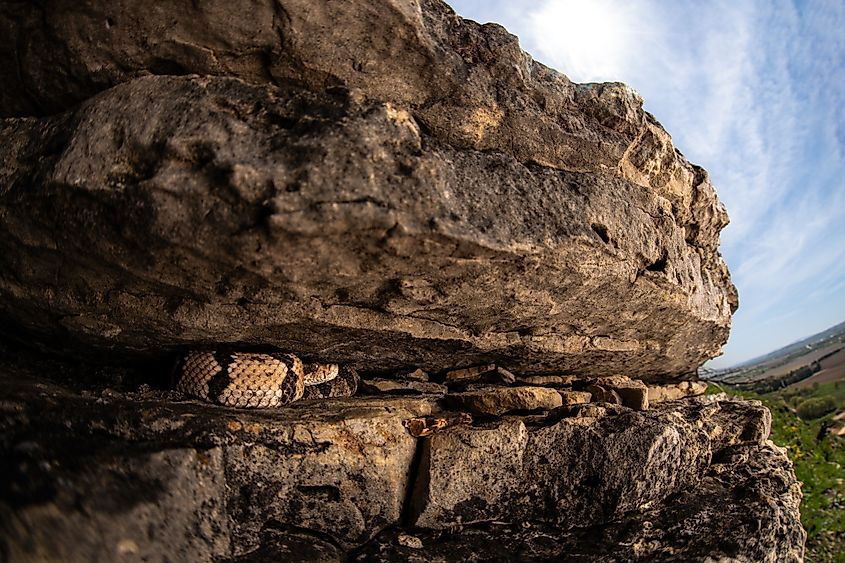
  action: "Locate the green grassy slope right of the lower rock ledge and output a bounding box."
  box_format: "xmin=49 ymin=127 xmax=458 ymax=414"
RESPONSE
xmin=708 ymin=380 xmax=845 ymax=563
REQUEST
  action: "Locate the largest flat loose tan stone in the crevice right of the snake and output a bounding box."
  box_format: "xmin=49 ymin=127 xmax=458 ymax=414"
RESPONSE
xmin=445 ymin=387 xmax=563 ymax=416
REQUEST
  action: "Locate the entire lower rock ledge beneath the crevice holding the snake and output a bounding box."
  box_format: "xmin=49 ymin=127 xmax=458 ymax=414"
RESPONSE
xmin=0 ymin=364 xmax=804 ymax=561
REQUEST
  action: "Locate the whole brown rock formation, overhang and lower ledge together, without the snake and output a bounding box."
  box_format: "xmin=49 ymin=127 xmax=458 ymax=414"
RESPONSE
xmin=0 ymin=0 xmax=804 ymax=562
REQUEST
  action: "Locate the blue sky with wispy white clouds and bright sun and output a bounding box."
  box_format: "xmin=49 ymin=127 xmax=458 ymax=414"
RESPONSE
xmin=448 ymin=0 xmax=845 ymax=368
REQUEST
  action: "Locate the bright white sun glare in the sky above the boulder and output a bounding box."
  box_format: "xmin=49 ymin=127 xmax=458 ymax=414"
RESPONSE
xmin=529 ymin=0 xmax=634 ymax=82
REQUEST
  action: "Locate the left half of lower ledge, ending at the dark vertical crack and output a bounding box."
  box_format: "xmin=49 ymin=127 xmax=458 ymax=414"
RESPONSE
xmin=0 ymin=364 xmax=432 ymax=561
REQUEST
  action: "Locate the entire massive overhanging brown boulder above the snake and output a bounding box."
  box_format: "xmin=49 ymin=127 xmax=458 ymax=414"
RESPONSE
xmin=0 ymin=0 xmax=736 ymax=381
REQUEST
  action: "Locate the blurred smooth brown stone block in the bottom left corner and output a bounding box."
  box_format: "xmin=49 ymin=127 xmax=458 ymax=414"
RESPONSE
xmin=0 ymin=448 xmax=231 ymax=562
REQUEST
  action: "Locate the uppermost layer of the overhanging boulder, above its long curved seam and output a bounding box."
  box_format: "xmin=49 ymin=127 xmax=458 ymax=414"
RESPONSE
xmin=0 ymin=0 xmax=736 ymax=276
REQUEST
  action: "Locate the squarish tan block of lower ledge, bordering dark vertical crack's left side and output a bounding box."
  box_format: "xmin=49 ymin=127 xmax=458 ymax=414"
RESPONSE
xmin=226 ymin=412 xmax=416 ymax=549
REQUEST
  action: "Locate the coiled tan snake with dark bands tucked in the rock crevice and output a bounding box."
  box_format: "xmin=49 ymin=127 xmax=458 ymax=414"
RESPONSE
xmin=176 ymin=351 xmax=358 ymax=408
